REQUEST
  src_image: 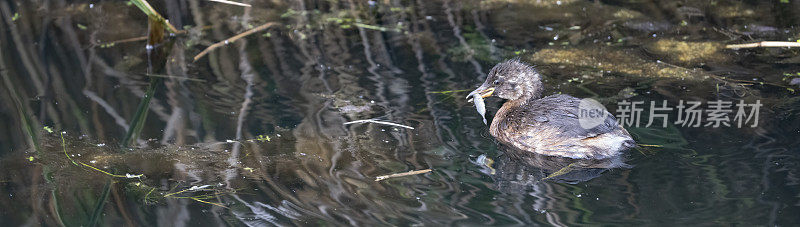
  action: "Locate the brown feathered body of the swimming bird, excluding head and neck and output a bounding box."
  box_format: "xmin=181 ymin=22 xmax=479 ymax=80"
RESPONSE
xmin=490 ymin=95 xmax=635 ymax=158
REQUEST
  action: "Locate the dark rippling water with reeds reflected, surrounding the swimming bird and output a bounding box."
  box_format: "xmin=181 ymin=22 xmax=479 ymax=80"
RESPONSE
xmin=0 ymin=0 xmax=800 ymax=226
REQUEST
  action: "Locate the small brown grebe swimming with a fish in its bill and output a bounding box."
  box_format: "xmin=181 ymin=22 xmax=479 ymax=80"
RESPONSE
xmin=470 ymin=60 xmax=636 ymax=159
